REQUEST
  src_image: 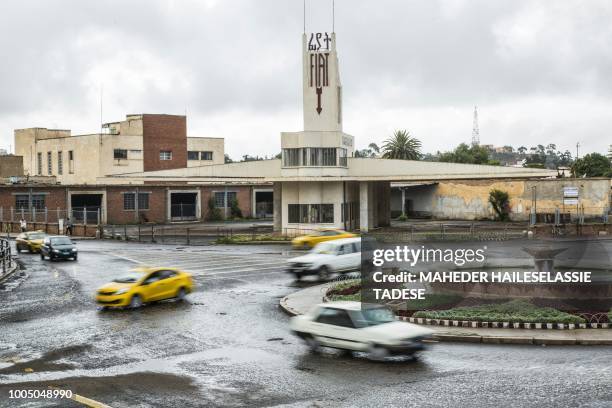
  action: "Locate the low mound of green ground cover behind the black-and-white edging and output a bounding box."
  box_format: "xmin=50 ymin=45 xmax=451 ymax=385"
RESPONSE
xmin=414 ymin=300 xmax=586 ymax=324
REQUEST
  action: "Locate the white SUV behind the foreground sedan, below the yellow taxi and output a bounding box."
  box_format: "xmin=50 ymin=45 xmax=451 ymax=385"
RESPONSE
xmin=287 ymin=238 xmax=361 ymax=280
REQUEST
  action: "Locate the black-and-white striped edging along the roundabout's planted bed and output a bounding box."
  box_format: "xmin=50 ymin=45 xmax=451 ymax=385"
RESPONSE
xmin=398 ymin=316 xmax=612 ymax=330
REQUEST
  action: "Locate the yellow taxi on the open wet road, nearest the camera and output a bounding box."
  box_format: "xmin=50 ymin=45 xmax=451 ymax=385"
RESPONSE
xmin=96 ymin=267 xmax=193 ymax=308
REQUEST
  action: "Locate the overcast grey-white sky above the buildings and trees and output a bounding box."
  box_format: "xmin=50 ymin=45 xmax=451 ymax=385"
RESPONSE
xmin=0 ymin=0 xmax=612 ymax=159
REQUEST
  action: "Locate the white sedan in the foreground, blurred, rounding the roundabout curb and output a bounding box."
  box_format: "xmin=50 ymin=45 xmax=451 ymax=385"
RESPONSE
xmin=290 ymin=301 xmax=433 ymax=359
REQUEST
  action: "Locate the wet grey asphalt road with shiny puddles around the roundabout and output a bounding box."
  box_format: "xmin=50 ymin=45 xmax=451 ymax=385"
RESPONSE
xmin=0 ymin=241 xmax=612 ymax=407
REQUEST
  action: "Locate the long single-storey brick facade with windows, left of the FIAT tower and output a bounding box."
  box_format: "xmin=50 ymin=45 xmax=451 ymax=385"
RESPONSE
xmin=0 ymin=184 xmax=271 ymax=224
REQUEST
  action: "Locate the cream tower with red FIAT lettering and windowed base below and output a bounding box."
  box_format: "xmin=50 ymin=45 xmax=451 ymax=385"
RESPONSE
xmin=275 ymin=32 xmax=357 ymax=230
